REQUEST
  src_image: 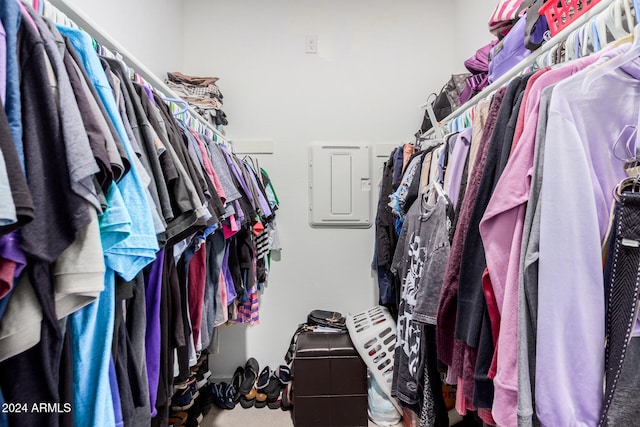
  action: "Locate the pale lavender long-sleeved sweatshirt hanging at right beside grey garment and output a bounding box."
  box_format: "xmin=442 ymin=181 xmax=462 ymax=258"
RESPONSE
xmin=536 ymin=47 xmax=640 ymax=426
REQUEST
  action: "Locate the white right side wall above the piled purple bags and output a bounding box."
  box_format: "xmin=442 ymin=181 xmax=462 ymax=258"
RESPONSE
xmin=451 ymin=0 xmax=498 ymax=73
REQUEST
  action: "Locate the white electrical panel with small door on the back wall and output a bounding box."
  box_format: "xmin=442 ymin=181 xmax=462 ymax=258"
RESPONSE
xmin=309 ymin=144 xmax=372 ymax=228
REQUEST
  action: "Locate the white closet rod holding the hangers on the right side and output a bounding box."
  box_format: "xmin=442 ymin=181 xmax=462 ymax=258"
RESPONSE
xmin=420 ymin=0 xmax=618 ymax=138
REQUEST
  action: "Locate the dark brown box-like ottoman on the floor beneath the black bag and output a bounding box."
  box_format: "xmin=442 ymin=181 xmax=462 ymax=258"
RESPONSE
xmin=293 ymin=332 xmax=368 ymax=427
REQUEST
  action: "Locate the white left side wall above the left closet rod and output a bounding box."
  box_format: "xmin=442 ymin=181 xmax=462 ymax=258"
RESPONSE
xmin=62 ymin=0 xmax=184 ymax=79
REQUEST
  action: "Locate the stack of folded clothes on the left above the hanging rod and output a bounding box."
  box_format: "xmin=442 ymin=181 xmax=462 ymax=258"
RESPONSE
xmin=166 ymin=72 xmax=229 ymax=126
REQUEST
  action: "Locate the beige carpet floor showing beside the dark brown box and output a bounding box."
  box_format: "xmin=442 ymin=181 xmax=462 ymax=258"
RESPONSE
xmin=200 ymin=405 xmax=402 ymax=427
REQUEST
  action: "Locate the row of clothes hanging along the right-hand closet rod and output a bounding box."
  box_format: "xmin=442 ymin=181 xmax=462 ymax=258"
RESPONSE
xmin=376 ymin=2 xmax=640 ymax=426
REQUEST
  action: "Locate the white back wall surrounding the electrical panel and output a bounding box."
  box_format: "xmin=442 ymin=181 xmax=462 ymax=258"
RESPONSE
xmin=183 ymin=0 xmax=454 ymax=377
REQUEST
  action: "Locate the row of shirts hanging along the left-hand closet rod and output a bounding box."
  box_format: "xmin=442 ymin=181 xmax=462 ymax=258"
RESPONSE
xmin=0 ymin=0 xmax=278 ymax=426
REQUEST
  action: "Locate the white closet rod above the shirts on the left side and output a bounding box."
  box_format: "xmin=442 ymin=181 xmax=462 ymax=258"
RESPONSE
xmin=47 ymin=0 xmax=228 ymax=143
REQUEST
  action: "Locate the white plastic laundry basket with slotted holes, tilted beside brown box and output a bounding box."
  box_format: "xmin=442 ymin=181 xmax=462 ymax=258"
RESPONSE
xmin=347 ymin=306 xmax=402 ymax=413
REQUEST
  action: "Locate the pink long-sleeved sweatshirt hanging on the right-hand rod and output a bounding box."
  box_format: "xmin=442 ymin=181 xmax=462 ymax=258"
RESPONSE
xmin=480 ymin=55 xmax=597 ymax=427
